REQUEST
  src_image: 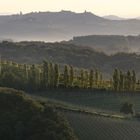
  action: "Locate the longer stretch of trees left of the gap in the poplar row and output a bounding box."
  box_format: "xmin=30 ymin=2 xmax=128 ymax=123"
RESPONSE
xmin=0 ymin=61 xmax=102 ymax=90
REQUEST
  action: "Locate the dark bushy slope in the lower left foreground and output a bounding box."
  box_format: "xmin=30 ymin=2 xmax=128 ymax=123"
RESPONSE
xmin=0 ymin=88 xmax=76 ymax=140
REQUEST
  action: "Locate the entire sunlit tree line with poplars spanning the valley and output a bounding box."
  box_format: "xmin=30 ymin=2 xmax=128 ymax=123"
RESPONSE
xmin=0 ymin=61 xmax=137 ymax=91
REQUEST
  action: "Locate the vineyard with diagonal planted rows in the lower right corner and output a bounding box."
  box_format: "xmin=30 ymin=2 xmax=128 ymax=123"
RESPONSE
xmin=65 ymin=112 xmax=140 ymax=140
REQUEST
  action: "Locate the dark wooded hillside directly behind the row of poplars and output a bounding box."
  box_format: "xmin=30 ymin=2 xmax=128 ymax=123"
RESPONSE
xmin=0 ymin=42 xmax=140 ymax=78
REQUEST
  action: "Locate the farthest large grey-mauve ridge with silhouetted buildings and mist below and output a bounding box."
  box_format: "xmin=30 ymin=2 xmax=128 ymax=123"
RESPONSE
xmin=0 ymin=10 xmax=140 ymax=41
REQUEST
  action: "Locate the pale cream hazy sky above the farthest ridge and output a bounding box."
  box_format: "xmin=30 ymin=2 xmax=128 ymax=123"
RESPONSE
xmin=0 ymin=0 xmax=140 ymax=17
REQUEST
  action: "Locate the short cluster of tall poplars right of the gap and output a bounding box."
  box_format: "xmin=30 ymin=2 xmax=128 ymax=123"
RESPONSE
xmin=113 ymin=69 xmax=137 ymax=91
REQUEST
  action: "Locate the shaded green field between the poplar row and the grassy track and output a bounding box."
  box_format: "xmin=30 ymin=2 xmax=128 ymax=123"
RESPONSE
xmin=33 ymin=90 xmax=140 ymax=113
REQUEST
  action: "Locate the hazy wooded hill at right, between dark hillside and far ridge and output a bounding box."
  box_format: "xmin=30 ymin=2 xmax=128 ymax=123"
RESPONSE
xmin=69 ymin=35 xmax=140 ymax=54
